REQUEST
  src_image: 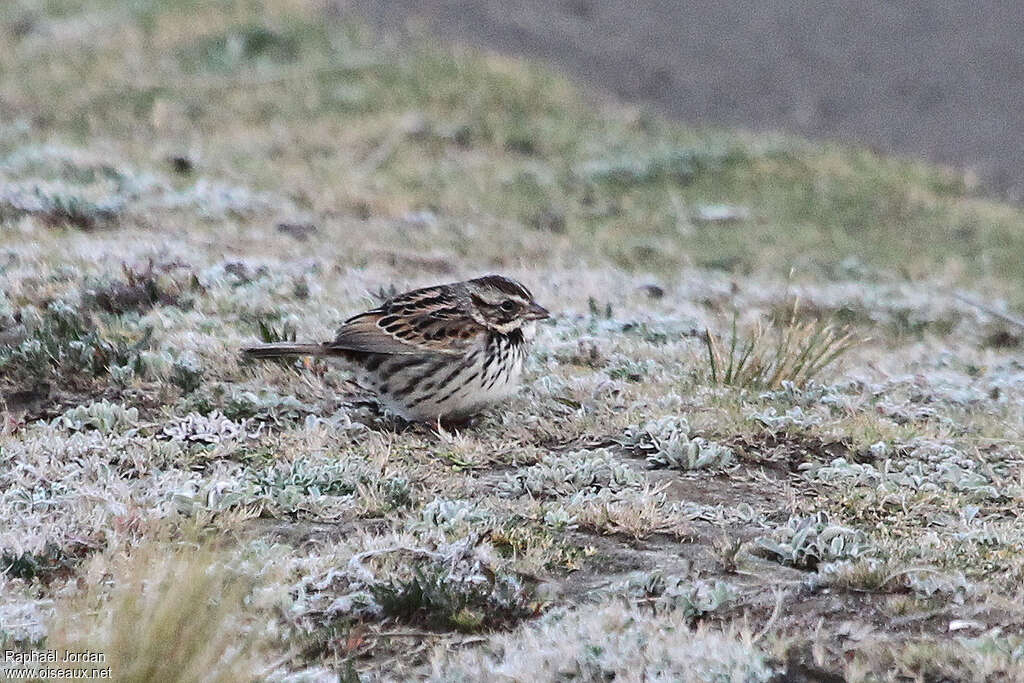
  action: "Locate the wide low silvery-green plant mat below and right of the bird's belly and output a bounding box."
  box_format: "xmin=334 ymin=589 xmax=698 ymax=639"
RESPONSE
xmin=498 ymin=449 xmax=646 ymax=498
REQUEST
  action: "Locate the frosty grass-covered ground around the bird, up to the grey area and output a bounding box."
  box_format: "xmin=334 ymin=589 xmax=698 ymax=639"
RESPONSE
xmin=0 ymin=0 xmax=1024 ymax=681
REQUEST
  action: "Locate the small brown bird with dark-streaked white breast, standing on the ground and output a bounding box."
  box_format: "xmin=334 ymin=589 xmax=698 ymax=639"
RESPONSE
xmin=242 ymin=275 xmax=549 ymax=421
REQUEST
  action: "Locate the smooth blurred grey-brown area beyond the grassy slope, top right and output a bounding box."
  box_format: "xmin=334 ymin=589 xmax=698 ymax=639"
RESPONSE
xmin=338 ymin=0 xmax=1024 ymax=200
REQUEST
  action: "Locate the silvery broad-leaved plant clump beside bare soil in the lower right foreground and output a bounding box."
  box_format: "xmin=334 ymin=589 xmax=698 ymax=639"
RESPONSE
xmin=754 ymin=512 xmax=870 ymax=570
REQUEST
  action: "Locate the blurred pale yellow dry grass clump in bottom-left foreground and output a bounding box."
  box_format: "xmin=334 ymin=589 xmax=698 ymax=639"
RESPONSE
xmin=47 ymin=544 xmax=259 ymax=682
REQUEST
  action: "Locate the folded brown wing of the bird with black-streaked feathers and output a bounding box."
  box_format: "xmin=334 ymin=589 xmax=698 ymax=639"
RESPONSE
xmin=327 ymin=288 xmax=485 ymax=355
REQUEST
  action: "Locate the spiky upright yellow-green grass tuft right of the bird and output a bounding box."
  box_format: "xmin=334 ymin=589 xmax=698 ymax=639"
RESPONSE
xmin=703 ymin=304 xmax=861 ymax=389
